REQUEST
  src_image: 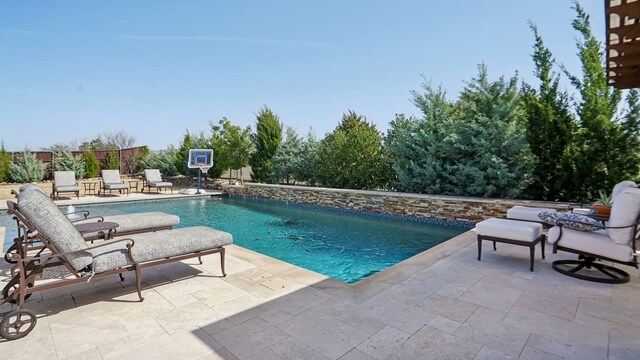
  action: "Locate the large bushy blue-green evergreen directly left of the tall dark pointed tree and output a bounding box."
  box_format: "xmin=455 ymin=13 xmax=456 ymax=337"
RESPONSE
xmin=454 ymin=64 xmax=532 ymax=198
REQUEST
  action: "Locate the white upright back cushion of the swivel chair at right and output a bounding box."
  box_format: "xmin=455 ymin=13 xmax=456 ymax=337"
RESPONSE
xmin=607 ymin=187 xmax=640 ymax=245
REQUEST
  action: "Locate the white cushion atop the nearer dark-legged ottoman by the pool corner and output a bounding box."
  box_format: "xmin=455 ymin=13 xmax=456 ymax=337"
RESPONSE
xmin=476 ymin=218 xmax=542 ymax=242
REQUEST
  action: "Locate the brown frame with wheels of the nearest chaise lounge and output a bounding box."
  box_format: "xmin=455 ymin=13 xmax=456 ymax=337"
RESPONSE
xmin=0 ymin=201 xmax=227 ymax=340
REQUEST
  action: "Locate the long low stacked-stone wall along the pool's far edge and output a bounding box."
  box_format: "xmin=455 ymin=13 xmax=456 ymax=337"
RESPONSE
xmin=223 ymin=184 xmax=569 ymax=222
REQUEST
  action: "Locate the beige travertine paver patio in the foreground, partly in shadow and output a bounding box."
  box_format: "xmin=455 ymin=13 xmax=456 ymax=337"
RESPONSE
xmin=0 ymin=224 xmax=640 ymax=360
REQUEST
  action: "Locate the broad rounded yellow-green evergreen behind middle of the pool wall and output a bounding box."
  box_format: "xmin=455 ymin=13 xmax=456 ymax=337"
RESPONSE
xmin=315 ymin=112 xmax=391 ymax=189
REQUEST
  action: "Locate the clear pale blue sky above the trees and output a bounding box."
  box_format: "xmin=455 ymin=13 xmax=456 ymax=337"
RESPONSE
xmin=0 ymin=0 xmax=604 ymax=151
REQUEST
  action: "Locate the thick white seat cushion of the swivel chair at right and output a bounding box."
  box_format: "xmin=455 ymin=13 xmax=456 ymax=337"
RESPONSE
xmin=547 ymin=226 xmax=633 ymax=262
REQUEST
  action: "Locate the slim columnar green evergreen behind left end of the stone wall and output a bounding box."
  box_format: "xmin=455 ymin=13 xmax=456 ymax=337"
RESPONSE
xmin=249 ymin=106 xmax=282 ymax=182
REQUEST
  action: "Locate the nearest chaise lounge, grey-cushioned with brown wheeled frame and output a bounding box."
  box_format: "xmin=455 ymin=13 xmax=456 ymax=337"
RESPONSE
xmin=0 ymin=184 xmax=233 ymax=340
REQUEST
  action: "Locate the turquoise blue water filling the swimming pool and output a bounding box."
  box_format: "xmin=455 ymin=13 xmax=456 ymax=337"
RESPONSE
xmin=0 ymin=196 xmax=467 ymax=283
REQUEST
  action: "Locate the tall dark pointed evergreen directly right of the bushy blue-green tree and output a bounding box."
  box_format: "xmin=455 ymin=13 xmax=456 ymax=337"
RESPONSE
xmin=522 ymin=25 xmax=576 ymax=201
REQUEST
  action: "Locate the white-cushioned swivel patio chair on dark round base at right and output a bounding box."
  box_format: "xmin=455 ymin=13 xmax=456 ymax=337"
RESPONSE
xmin=548 ymin=187 xmax=640 ymax=284
